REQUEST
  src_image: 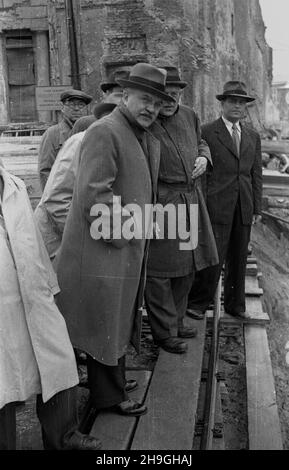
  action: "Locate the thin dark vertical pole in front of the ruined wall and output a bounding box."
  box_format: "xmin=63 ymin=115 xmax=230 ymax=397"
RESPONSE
xmin=65 ymin=0 xmax=81 ymax=90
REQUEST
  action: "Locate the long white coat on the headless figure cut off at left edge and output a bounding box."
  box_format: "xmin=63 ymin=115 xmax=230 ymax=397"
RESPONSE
xmin=0 ymin=162 xmax=79 ymax=409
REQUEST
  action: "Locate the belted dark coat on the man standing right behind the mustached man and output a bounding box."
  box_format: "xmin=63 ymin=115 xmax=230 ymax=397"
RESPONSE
xmin=148 ymin=106 xmax=218 ymax=277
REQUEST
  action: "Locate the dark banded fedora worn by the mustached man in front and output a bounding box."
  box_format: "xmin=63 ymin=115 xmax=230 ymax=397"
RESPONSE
xmin=117 ymin=62 xmax=175 ymax=103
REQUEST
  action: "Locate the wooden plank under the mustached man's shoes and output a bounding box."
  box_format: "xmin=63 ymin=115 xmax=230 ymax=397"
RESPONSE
xmin=90 ymin=371 xmax=152 ymax=450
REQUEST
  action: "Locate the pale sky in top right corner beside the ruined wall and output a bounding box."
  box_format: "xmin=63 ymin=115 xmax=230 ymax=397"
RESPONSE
xmin=260 ymin=0 xmax=289 ymax=81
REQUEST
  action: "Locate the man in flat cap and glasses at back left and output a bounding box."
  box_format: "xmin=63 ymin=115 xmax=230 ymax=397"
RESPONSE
xmin=38 ymin=90 xmax=92 ymax=190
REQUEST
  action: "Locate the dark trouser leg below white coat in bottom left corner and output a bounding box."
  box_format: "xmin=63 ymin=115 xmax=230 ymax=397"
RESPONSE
xmin=0 ymin=403 xmax=16 ymax=450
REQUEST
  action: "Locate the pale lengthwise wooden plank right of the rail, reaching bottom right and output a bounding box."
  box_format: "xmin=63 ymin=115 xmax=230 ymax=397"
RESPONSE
xmin=244 ymin=325 xmax=283 ymax=450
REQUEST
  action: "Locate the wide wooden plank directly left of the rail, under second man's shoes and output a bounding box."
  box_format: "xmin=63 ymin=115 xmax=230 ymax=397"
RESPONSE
xmin=131 ymin=318 xmax=206 ymax=450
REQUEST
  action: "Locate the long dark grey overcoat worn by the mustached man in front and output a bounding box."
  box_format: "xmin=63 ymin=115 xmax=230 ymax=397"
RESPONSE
xmin=56 ymin=108 xmax=160 ymax=366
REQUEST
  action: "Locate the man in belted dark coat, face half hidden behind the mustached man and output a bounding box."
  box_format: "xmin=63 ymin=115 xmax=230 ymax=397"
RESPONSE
xmin=145 ymin=66 xmax=218 ymax=354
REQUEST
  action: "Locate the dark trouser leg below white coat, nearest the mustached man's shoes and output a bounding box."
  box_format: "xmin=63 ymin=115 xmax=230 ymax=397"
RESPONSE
xmin=36 ymin=387 xmax=78 ymax=450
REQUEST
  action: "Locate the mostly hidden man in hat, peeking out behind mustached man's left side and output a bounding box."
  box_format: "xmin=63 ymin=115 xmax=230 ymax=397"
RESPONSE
xmin=72 ymin=67 xmax=129 ymax=134
